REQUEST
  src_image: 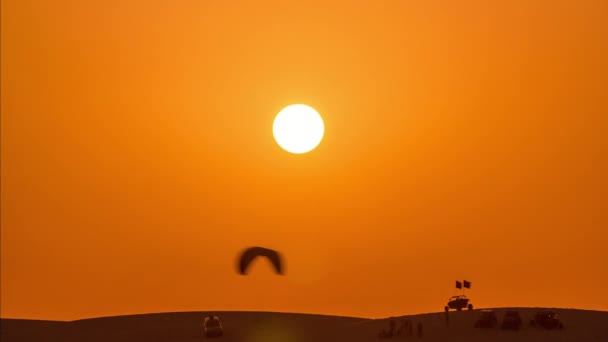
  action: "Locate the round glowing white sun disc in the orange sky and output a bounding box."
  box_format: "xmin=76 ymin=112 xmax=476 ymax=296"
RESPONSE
xmin=272 ymin=104 xmax=325 ymax=154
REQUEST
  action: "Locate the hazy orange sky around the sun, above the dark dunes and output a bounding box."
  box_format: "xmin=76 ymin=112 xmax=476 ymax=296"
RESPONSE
xmin=0 ymin=0 xmax=608 ymax=319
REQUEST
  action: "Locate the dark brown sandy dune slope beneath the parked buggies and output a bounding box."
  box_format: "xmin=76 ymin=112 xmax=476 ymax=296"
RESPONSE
xmin=0 ymin=308 xmax=608 ymax=342
